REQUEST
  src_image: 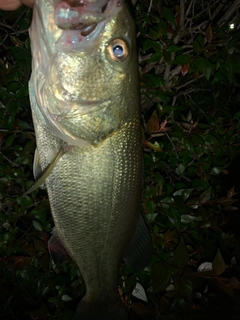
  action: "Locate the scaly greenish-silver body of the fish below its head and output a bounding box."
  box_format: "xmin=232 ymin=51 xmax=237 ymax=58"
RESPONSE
xmin=32 ymin=82 xmax=142 ymax=297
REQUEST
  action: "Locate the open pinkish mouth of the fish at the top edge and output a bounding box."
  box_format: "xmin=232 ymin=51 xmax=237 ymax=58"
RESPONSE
xmin=53 ymin=0 xmax=122 ymax=45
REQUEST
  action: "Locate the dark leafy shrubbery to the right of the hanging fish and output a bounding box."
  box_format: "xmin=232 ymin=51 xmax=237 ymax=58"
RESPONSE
xmin=137 ymin=0 xmax=240 ymax=313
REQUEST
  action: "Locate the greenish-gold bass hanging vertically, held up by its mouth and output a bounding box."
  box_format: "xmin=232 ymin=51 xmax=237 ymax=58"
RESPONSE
xmin=29 ymin=0 xmax=152 ymax=320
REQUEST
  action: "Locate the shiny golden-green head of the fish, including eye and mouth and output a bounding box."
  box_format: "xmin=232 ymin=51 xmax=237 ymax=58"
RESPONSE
xmin=30 ymin=0 xmax=139 ymax=145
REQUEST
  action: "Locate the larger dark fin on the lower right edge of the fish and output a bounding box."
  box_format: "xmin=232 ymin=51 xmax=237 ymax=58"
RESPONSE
xmin=123 ymin=214 xmax=152 ymax=272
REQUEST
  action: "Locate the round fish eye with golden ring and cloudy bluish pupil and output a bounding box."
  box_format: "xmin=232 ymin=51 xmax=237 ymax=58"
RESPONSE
xmin=107 ymin=39 xmax=129 ymax=62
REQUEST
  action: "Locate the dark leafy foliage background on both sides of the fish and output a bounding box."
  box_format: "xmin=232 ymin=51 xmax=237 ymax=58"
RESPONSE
xmin=0 ymin=0 xmax=240 ymax=320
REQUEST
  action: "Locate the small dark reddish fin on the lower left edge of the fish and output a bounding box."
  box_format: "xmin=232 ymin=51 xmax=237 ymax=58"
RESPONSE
xmin=48 ymin=228 xmax=70 ymax=264
